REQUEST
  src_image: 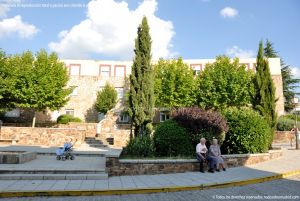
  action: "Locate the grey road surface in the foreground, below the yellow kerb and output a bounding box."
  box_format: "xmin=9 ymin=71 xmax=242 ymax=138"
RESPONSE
xmin=2 ymin=175 xmax=300 ymax=201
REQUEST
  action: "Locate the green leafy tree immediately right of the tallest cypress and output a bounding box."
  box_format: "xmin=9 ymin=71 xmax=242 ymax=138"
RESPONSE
xmin=154 ymin=58 xmax=196 ymax=108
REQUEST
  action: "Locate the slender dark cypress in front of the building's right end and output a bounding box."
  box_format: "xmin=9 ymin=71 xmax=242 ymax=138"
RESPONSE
xmin=253 ymin=41 xmax=277 ymax=145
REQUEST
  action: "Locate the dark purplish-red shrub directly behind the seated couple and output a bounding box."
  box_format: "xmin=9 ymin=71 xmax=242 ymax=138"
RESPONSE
xmin=171 ymin=107 xmax=228 ymax=146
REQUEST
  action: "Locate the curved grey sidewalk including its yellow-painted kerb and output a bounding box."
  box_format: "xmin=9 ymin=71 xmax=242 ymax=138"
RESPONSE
xmin=0 ymin=150 xmax=300 ymax=196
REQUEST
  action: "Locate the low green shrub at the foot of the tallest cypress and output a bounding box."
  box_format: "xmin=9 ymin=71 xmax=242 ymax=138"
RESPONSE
xmin=122 ymin=135 xmax=155 ymax=157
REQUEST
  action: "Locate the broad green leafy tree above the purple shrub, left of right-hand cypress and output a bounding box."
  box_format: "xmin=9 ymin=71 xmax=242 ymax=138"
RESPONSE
xmin=197 ymin=56 xmax=253 ymax=110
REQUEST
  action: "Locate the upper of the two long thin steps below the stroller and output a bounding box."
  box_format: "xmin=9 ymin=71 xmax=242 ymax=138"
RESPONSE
xmin=0 ymin=169 xmax=105 ymax=175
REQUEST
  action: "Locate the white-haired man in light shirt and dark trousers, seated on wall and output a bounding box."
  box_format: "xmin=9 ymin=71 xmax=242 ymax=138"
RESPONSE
xmin=196 ymin=138 xmax=216 ymax=173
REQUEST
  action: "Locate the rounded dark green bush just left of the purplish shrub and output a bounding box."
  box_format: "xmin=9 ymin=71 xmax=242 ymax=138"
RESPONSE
xmin=153 ymin=120 xmax=193 ymax=156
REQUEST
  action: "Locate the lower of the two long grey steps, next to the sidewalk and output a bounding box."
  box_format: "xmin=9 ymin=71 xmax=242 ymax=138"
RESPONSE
xmin=0 ymin=173 xmax=108 ymax=180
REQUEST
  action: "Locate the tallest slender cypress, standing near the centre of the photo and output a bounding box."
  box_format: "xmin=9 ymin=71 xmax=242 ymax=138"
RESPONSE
xmin=129 ymin=17 xmax=154 ymax=136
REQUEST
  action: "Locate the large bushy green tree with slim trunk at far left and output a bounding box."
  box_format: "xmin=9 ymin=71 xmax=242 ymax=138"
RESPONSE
xmin=1 ymin=50 xmax=72 ymax=127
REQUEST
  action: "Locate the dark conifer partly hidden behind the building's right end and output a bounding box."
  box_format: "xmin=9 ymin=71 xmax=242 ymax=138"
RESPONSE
xmin=264 ymin=40 xmax=300 ymax=112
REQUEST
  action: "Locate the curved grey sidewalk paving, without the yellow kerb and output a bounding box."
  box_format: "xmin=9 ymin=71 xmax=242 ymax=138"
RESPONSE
xmin=0 ymin=150 xmax=300 ymax=192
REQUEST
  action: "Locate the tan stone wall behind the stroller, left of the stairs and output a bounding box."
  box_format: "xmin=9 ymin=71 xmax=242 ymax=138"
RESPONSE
xmin=0 ymin=127 xmax=85 ymax=146
